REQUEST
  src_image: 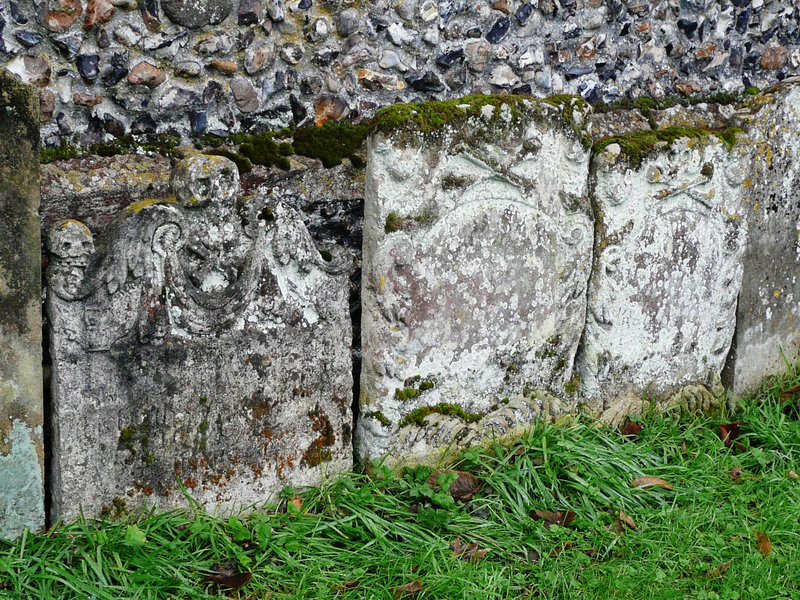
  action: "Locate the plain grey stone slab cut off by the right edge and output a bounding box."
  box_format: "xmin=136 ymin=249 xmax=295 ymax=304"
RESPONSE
xmin=724 ymin=82 xmax=800 ymax=394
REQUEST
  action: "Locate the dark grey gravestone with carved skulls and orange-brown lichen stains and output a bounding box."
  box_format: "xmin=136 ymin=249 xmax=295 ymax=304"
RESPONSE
xmin=48 ymin=155 xmax=352 ymax=519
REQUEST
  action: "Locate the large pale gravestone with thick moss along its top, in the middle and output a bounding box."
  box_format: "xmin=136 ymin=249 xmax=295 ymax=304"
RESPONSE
xmin=357 ymin=97 xmax=592 ymax=461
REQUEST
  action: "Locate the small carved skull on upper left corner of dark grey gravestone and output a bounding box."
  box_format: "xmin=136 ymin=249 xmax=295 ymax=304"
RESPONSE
xmin=48 ymin=220 xmax=94 ymax=300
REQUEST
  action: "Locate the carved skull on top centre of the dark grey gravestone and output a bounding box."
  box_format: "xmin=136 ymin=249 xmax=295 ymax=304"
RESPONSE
xmin=171 ymin=154 xmax=239 ymax=208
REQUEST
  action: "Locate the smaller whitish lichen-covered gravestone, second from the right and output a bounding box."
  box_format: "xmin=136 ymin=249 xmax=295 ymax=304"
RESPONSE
xmin=578 ymin=131 xmax=747 ymax=422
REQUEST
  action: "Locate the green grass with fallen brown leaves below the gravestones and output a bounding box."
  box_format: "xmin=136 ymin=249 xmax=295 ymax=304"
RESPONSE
xmin=0 ymin=371 xmax=800 ymax=600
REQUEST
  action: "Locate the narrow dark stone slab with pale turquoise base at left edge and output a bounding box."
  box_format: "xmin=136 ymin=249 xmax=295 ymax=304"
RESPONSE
xmin=0 ymin=69 xmax=44 ymax=538
